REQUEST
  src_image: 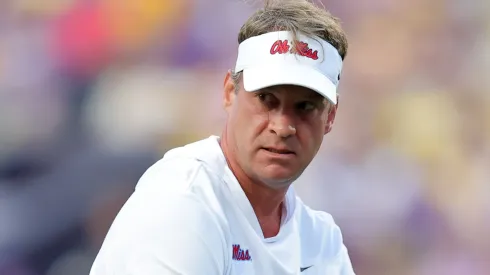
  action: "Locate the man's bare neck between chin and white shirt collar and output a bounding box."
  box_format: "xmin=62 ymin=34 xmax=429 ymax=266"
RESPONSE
xmin=220 ymin=130 xmax=288 ymax=238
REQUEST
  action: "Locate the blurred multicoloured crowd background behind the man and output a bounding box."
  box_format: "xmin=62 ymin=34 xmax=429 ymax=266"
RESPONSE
xmin=0 ymin=0 xmax=490 ymax=275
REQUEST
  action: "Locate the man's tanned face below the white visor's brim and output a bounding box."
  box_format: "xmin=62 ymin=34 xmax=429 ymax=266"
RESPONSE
xmin=223 ymin=73 xmax=337 ymax=188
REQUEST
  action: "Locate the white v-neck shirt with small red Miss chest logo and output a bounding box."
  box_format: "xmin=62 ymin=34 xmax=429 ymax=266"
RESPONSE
xmin=90 ymin=136 xmax=354 ymax=275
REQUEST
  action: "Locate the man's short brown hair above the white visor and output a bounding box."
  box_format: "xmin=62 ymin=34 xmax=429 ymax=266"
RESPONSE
xmin=232 ymin=0 xmax=348 ymax=90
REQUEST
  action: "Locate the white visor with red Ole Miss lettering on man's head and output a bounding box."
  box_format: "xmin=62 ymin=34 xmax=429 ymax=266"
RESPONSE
xmin=235 ymin=31 xmax=342 ymax=104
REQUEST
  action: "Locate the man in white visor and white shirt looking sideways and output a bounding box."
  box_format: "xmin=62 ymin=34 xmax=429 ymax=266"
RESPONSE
xmin=91 ymin=0 xmax=354 ymax=275
